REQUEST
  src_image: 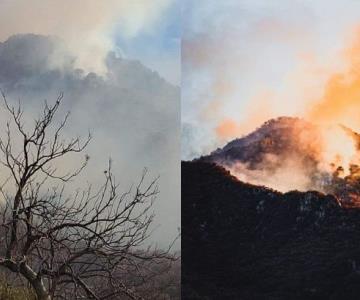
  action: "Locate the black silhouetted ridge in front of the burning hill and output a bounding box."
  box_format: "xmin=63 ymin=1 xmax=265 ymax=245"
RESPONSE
xmin=181 ymin=161 xmax=360 ymax=300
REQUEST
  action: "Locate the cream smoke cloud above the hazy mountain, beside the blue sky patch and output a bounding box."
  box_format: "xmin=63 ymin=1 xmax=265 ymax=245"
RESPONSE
xmin=0 ymin=0 xmax=171 ymax=74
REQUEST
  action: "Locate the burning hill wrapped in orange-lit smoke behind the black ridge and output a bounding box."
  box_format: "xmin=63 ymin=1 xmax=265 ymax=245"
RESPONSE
xmin=201 ymin=117 xmax=360 ymax=207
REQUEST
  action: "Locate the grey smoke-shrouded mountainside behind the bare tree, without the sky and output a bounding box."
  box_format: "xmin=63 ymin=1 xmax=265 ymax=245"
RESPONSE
xmin=0 ymin=34 xmax=180 ymax=245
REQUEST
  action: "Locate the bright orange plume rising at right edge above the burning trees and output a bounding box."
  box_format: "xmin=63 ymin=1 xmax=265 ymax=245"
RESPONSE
xmin=307 ymin=26 xmax=360 ymax=178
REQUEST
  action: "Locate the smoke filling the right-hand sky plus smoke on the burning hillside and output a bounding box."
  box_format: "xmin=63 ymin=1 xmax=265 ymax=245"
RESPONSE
xmin=182 ymin=0 xmax=360 ymax=199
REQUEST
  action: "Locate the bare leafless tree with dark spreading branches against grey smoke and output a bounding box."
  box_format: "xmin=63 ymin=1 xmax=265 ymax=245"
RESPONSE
xmin=0 ymin=93 xmax=173 ymax=300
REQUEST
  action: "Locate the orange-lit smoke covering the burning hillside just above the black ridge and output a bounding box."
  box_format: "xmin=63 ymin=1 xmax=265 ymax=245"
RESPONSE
xmin=219 ymin=119 xmax=360 ymax=196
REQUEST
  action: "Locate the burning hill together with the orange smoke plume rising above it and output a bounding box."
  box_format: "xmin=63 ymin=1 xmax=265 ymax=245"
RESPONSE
xmin=208 ymin=26 xmax=360 ymax=207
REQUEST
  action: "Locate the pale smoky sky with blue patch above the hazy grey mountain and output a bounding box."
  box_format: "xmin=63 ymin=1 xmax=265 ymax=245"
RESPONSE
xmin=0 ymin=0 xmax=180 ymax=84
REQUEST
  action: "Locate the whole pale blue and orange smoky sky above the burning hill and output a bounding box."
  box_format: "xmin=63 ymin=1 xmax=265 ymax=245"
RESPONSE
xmin=182 ymin=0 xmax=360 ymax=159
